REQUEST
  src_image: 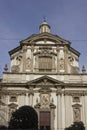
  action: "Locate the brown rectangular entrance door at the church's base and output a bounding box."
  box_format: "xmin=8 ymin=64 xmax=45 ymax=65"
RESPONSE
xmin=40 ymin=111 xmax=51 ymax=130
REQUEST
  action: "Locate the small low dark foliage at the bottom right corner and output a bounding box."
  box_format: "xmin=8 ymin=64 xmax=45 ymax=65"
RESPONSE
xmin=65 ymin=121 xmax=85 ymax=130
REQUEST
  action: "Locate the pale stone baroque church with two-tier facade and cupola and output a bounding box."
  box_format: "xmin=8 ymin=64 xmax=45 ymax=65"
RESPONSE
xmin=0 ymin=20 xmax=87 ymax=130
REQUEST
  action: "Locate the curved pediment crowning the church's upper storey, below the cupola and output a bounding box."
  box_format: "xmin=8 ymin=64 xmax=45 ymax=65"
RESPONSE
xmin=20 ymin=32 xmax=70 ymax=44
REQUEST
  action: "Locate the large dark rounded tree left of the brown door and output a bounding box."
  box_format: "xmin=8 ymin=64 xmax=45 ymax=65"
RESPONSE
xmin=8 ymin=106 xmax=38 ymax=130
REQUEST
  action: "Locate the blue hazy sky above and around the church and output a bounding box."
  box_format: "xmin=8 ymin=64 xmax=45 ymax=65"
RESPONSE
xmin=0 ymin=0 xmax=87 ymax=76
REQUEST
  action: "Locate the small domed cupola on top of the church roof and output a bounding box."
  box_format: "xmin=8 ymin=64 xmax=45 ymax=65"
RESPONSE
xmin=39 ymin=19 xmax=50 ymax=33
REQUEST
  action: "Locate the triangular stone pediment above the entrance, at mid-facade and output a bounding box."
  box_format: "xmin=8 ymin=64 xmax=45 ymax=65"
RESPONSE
xmin=27 ymin=75 xmax=64 ymax=87
